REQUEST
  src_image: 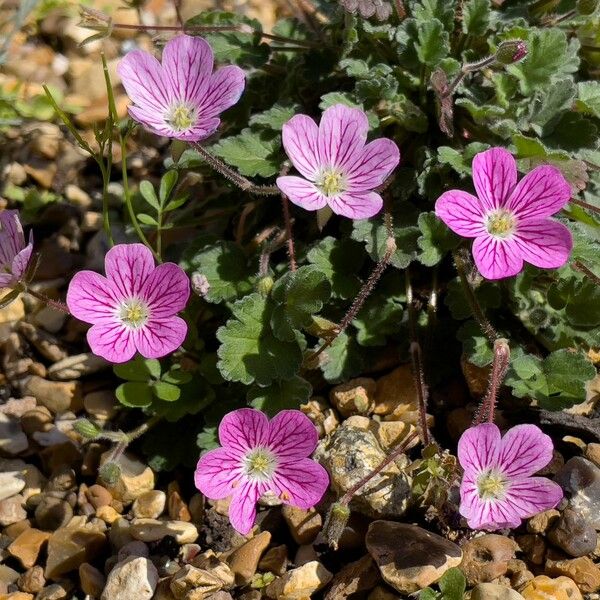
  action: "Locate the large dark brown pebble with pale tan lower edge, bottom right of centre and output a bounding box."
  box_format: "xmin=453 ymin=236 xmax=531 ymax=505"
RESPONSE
xmin=366 ymin=521 xmax=462 ymax=594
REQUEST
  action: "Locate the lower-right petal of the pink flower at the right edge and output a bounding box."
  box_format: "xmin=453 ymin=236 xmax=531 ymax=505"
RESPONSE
xmin=513 ymin=219 xmax=573 ymax=269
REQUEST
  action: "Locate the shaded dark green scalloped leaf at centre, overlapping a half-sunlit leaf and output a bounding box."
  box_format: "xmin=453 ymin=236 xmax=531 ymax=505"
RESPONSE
xmin=271 ymin=265 xmax=331 ymax=341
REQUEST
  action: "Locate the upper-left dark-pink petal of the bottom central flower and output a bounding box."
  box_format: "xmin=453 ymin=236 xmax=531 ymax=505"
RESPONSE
xmin=219 ymin=408 xmax=269 ymax=452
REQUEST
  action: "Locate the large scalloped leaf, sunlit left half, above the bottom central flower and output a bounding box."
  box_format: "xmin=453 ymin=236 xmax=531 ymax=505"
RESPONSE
xmin=217 ymin=293 xmax=302 ymax=385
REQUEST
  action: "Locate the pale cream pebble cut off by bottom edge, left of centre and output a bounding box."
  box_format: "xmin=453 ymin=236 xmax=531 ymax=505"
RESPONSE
xmin=101 ymin=556 xmax=158 ymax=600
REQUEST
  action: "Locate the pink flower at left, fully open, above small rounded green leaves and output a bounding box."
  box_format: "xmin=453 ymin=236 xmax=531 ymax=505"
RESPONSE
xmin=67 ymin=244 xmax=190 ymax=363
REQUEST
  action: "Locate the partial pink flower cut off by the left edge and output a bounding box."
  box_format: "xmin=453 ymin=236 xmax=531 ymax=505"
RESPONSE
xmin=0 ymin=210 xmax=33 ymax=288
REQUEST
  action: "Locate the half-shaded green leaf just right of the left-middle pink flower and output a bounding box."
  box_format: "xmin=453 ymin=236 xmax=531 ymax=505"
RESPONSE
xmin=190 ymin=241 xmax=255 ymax=303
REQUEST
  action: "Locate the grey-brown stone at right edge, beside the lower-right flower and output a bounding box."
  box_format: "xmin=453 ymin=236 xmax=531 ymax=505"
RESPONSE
xmin=555 ymin=456 xmax=600 ymax=530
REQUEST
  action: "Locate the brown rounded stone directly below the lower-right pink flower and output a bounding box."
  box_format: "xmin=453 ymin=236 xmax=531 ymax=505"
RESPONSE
xmin=459 ymin=533 xmax=518 ymax=586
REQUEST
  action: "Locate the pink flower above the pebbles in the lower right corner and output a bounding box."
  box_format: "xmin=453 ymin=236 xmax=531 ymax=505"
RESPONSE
xmin=458 ymin=423 xmax=563 ymax=530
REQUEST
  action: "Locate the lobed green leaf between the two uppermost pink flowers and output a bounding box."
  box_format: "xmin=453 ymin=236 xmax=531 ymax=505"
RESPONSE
xmin=211 ymin=129 xmax=281 ymax=177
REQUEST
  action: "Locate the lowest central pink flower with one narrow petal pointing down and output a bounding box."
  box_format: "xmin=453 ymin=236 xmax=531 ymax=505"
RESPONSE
xmin=194 ymin=408 xmax=329 ymax=535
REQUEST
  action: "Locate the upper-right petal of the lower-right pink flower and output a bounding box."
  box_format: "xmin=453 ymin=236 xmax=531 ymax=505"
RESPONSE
xmin=498 ymin=424 xmax=553 ymax=478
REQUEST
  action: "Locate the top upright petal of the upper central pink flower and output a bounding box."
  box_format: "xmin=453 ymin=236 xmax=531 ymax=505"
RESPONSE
xmin=318 ymin=104 xmax=369 ymax=171
